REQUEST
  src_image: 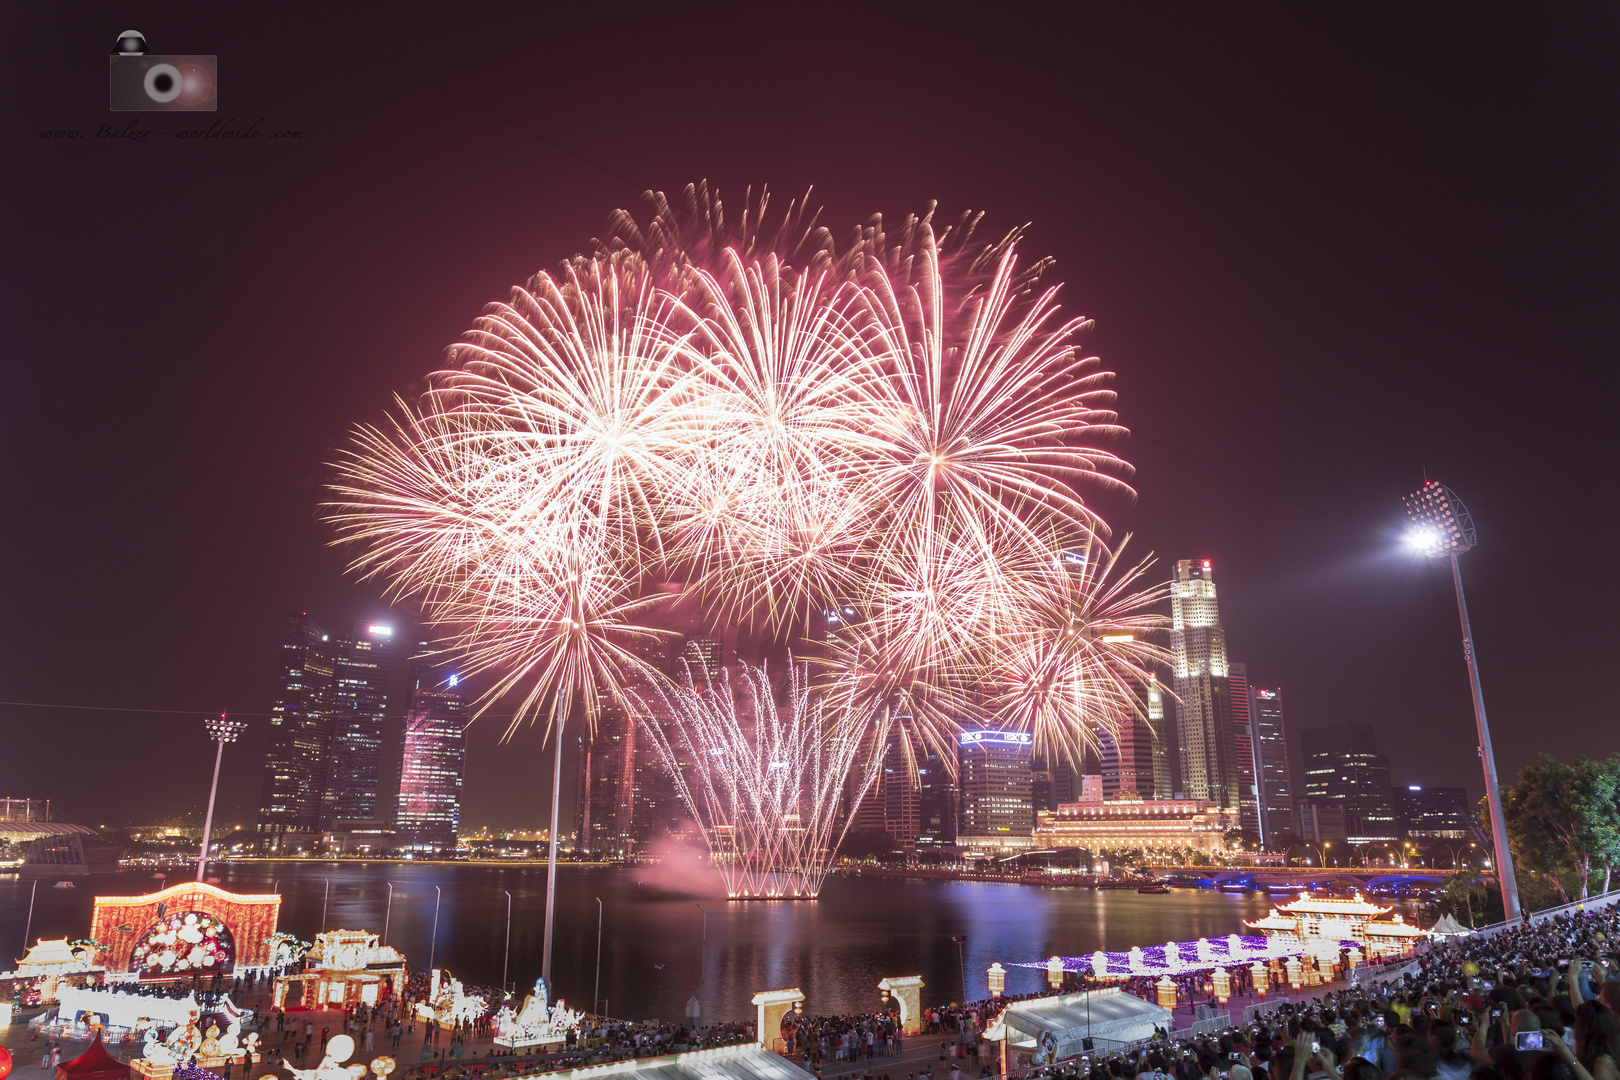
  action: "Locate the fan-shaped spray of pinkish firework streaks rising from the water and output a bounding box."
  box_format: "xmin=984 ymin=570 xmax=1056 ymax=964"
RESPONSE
xmin=632 ymin=664 xmax=880 ymax=900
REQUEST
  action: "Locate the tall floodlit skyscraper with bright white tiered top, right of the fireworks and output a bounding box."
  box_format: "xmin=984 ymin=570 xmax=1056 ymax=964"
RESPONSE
xmin=1170 ymin=559 xmax=1241 ymax=810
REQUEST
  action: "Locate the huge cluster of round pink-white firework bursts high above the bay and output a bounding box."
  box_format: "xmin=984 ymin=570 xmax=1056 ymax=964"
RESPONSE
xmin=327 ymin=188 xmax=1163 ymax=786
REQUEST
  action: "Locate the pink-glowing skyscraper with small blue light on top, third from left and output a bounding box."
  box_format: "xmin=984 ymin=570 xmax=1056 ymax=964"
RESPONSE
xmin=394 ymin=657 xmax=467 ymax=850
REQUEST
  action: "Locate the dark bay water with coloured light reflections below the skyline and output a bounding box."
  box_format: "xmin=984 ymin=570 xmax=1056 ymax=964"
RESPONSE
xmin=0 ymin=861 xmax=1268 ymax=1020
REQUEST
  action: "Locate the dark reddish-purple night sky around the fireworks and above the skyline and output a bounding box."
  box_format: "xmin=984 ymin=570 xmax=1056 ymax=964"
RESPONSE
xmin=0 ymin=3 xmax=1620 ymax=827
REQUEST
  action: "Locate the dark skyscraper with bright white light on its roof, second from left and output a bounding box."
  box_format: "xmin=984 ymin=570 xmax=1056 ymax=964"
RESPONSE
xmin=321 ymin=622 xmax=394 ymax=824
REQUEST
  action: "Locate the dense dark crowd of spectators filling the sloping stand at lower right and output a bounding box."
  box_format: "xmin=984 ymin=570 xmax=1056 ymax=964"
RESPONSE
xmin=1019 ymin=910 xmax=1620 ymax=1080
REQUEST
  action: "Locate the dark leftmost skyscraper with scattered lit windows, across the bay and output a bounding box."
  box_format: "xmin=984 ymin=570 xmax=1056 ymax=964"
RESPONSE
xmin=258 ymin=612 xmax=335 ymax=850
